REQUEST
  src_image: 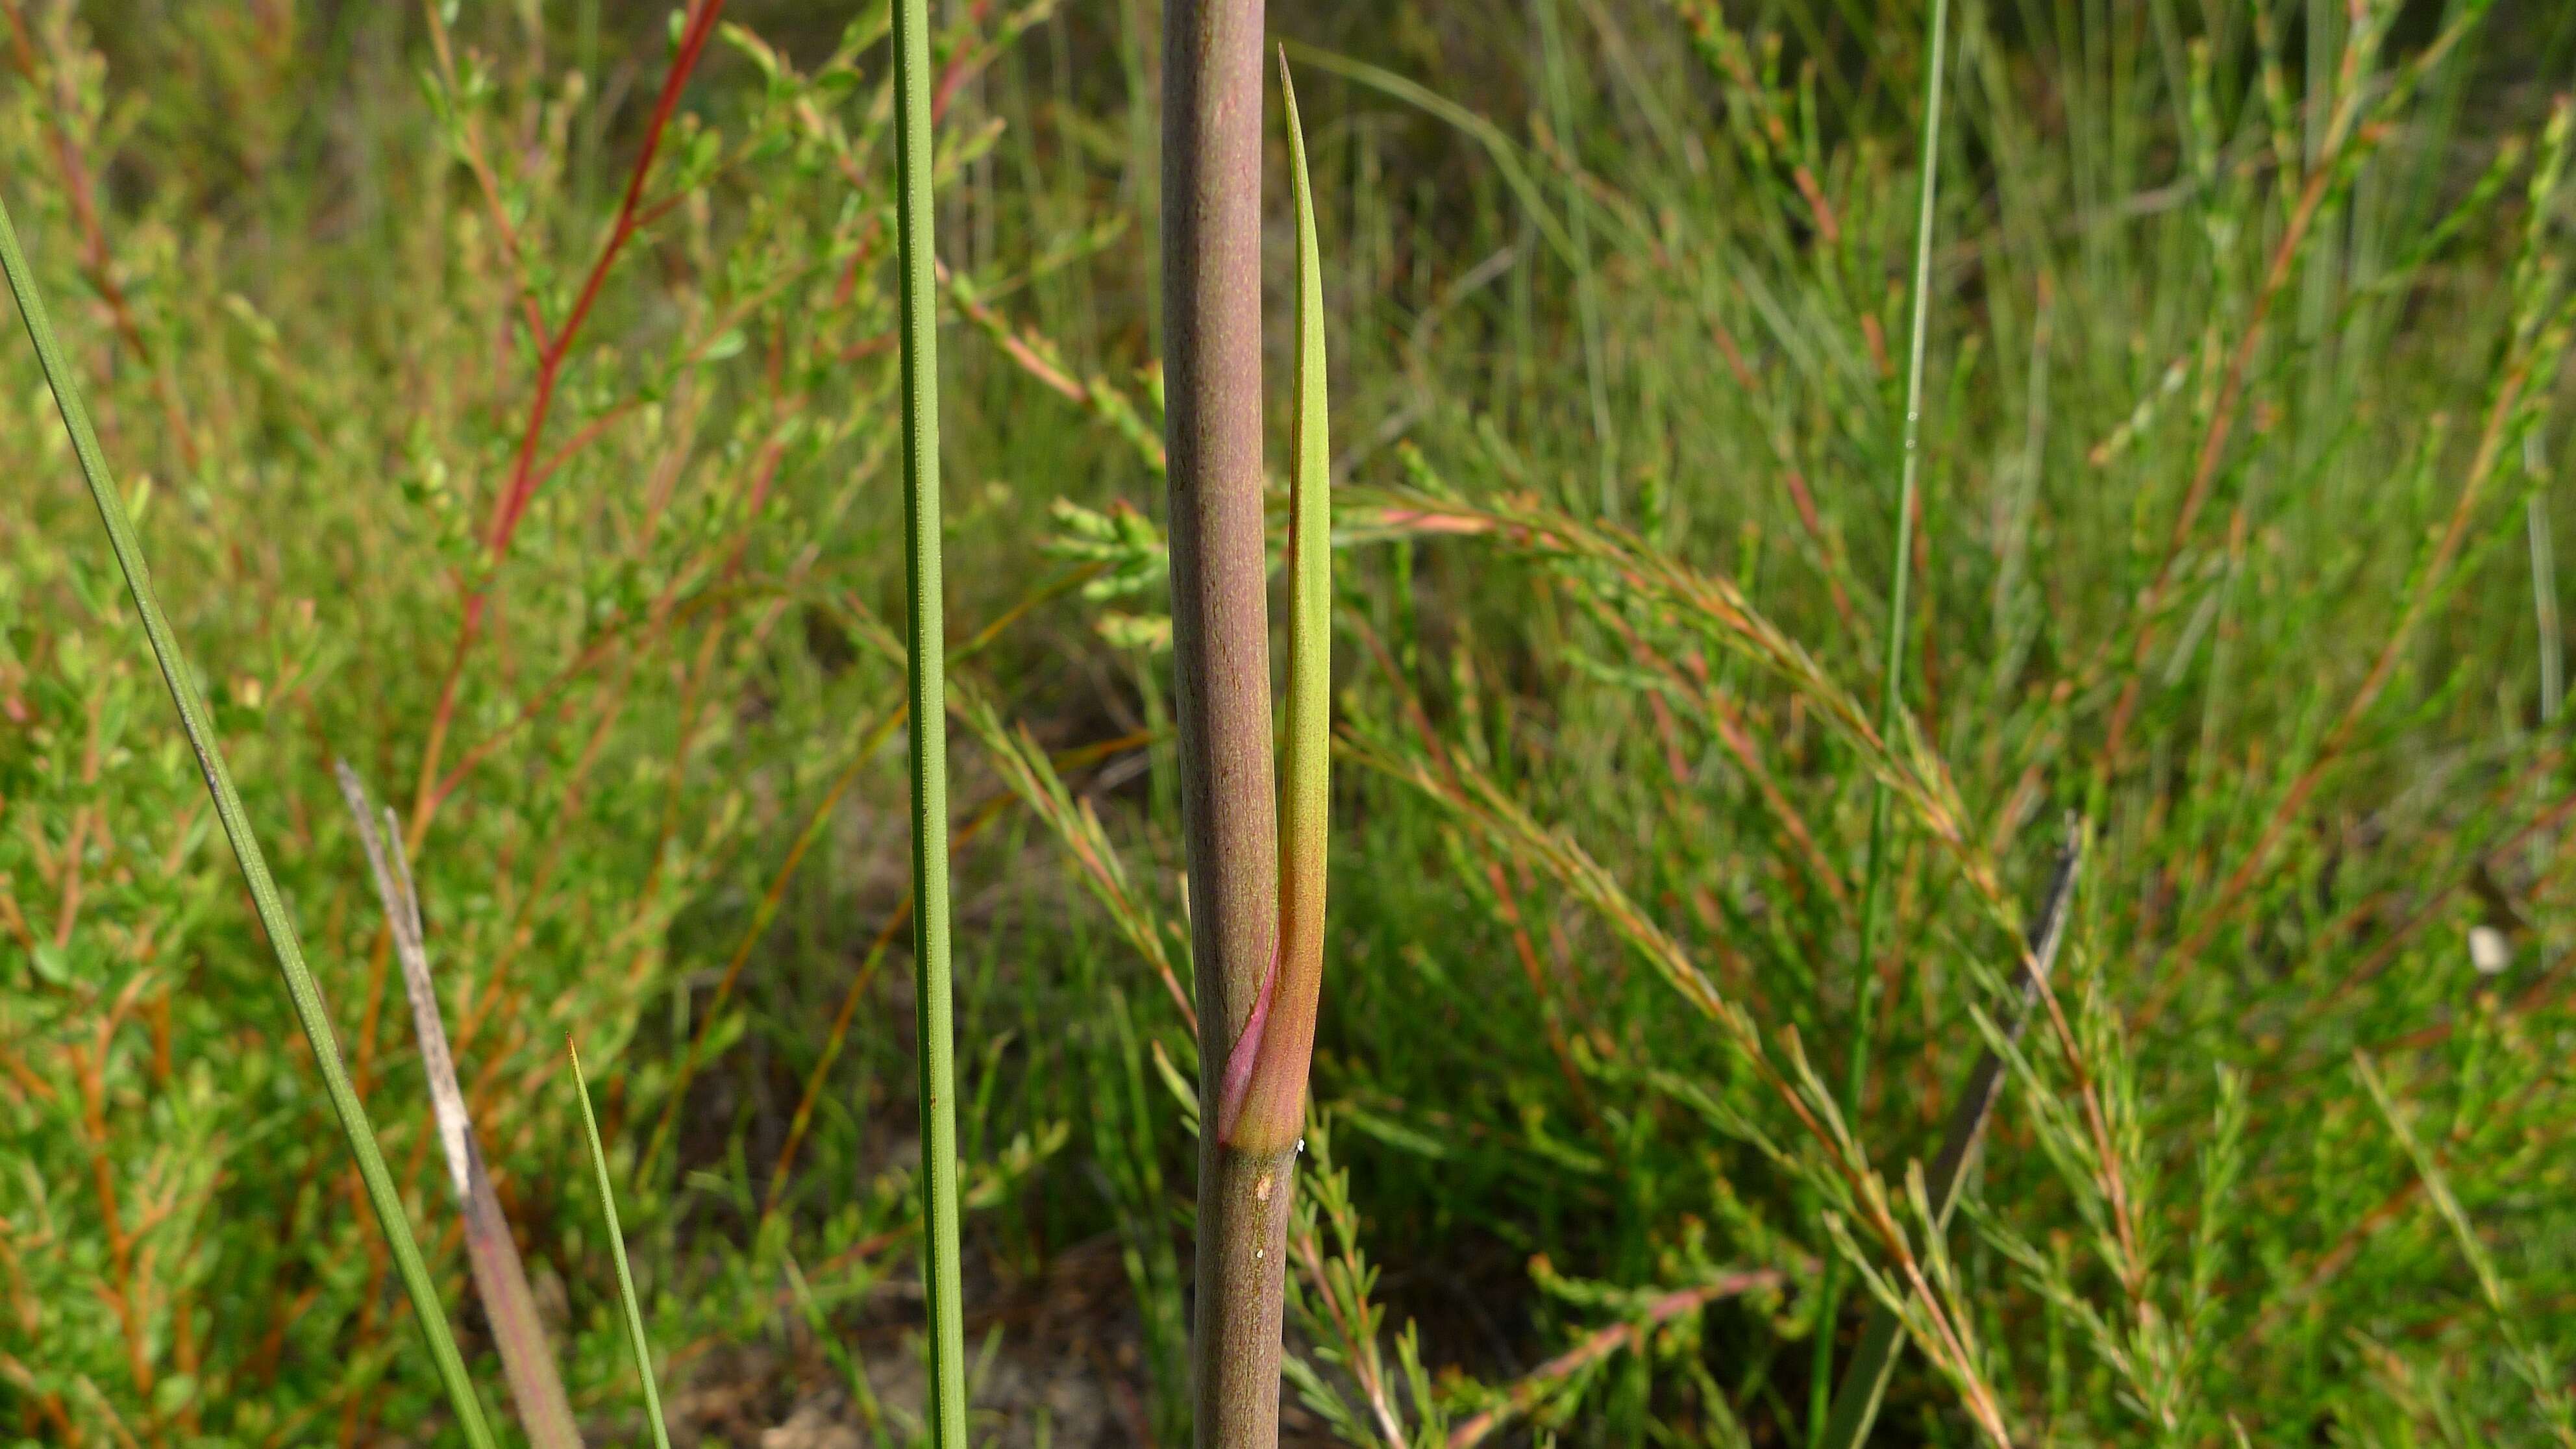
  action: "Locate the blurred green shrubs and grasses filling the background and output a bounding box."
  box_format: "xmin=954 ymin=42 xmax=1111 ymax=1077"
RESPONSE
xmin=0 ymin=0 xmax=2576 ymax=1449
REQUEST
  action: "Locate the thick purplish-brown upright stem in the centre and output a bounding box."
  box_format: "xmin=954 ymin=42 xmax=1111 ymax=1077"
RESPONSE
xmin=1162 ymin=0 xmax=1296 ymax=1449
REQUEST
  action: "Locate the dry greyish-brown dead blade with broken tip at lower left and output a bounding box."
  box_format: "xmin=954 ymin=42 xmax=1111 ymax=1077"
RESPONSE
xmin=332 ymin=761 xmax=582 ymax=1449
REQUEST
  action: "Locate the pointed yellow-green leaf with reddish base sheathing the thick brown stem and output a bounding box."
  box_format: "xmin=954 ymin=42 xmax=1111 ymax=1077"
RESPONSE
xmin=1219 ymin=54 xmax=1331 ymax=1152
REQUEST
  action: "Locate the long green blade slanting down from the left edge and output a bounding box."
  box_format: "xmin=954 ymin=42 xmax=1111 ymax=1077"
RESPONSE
xmin=0 ymin=185 xmax=492 ymax=1449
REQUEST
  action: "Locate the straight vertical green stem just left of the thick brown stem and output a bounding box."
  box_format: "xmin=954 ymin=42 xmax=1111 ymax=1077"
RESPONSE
xmin=894 ymin=0 xmax=966 ymax=1449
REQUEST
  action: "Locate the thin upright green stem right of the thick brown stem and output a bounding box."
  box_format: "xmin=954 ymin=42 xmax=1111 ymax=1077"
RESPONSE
xmin=1809 ymin=0 xmax=1950 ymax=1441
